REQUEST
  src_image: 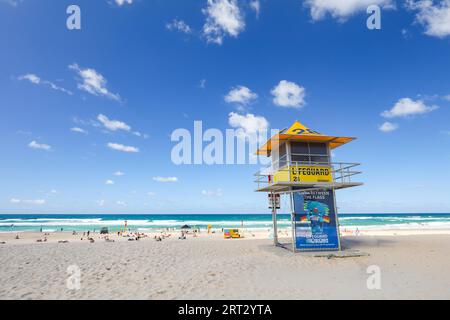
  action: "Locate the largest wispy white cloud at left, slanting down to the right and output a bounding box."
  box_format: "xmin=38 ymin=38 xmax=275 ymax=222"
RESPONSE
xmin=69 ymin=63 xmax=121 ymax=101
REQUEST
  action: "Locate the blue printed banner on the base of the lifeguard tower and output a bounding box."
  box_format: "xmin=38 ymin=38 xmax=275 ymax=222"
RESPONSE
xmin=294 ymin=190 xmax=339 ymax=251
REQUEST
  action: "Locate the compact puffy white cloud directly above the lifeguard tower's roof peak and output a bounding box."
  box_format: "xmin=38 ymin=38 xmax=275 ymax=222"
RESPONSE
xmin=271 ymin=80 xmax=305 ymax=108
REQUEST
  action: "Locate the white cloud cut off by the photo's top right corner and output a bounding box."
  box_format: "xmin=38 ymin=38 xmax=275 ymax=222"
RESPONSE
xmin=406 ymin=0 xmax=450 ymax=38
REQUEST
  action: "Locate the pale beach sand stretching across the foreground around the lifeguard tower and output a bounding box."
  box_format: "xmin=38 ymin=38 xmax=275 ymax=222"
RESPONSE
xmin=0 ymin=231 xmax=450 ymax=299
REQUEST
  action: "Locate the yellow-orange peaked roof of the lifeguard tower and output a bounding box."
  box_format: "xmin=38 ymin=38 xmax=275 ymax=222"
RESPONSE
xmin=256 ymin=121 xmax=356 ymax=156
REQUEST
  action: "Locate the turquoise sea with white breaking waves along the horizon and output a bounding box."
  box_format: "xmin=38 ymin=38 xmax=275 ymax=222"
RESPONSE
xmin=0 ymin=213 xmax=450 ymax=232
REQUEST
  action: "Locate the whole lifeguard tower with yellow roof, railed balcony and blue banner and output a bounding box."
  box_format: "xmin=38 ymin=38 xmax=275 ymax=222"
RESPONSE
xmin=255 ymin=121 xmax=362 ymax=252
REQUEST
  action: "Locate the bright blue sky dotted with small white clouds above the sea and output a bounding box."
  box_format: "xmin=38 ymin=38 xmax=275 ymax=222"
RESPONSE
xmin=0 ymin=0 xmax=450 ymax=213
